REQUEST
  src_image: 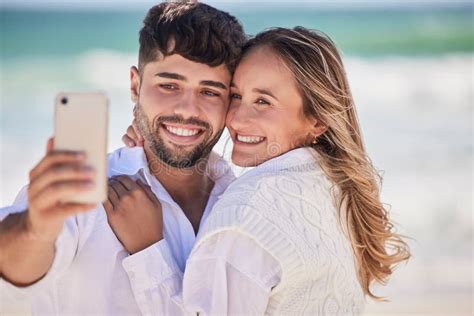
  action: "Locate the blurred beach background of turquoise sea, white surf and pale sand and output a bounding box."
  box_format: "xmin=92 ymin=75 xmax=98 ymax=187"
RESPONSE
xmin=0 ymin=0 xmax=474 ymax=315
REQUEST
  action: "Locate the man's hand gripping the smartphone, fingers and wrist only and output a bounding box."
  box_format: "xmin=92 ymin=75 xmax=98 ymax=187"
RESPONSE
xmin=26 ymin=139 xmax=95 ymax=241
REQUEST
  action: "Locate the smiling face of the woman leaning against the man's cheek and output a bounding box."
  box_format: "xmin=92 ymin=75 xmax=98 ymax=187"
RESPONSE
xmin=226 ymin=46 xmax=316 ymax=167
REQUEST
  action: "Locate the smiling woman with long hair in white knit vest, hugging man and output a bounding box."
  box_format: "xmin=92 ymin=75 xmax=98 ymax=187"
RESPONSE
xmin=120 ymin=27 xmax=409 ymax=315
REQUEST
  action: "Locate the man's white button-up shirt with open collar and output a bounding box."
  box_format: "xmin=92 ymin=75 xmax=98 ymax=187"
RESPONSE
xmin=0 ymin=148 xmax=234 ymax=316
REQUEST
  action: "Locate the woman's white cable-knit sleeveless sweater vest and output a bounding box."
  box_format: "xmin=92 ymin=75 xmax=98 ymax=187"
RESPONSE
xmin=194 ymin=148 xmax=365 ymax=315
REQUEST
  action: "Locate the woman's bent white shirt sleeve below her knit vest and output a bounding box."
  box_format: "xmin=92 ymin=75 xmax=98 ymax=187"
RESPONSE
xmin=120 ymin=230 xmax=281 ymax=315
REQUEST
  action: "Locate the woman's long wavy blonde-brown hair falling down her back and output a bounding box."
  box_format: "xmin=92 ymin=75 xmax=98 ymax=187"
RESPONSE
xmin=244 ymin=27 xmax=410 ymax=299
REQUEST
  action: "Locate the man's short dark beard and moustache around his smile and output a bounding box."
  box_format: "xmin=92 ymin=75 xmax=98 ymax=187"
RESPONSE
xmin=135 ymin=103 xmax=223 ymax=168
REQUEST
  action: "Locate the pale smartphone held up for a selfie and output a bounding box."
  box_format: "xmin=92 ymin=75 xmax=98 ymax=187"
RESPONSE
xmin=54 ymin=92 xmax=109 ymax=204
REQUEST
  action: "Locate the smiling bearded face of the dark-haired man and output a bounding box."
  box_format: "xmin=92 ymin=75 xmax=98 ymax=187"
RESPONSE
xmin=131 ymin=54 xmax=231 ymax=168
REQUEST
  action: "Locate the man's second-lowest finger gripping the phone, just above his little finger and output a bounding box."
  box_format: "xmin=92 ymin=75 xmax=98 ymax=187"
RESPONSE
xmin=30 ymin=181 xmax=94 ymax=209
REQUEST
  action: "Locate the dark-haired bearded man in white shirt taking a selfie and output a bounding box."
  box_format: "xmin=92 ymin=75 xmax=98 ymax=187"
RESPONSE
xmin=0 ymin=2 xmax=245 ymax=315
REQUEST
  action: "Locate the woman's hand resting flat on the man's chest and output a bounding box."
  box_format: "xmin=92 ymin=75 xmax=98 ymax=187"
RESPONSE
xmin=104 ymin=176 xmax=163 ymax=254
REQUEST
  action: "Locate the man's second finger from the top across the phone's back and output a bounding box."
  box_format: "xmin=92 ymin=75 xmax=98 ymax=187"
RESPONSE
xmin=29 ymin=164 xmax=95 ymax=198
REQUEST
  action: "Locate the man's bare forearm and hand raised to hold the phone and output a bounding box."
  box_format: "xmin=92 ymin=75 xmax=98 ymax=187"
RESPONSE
xmin=0 ymin=140 xmax=95 ymax=286
